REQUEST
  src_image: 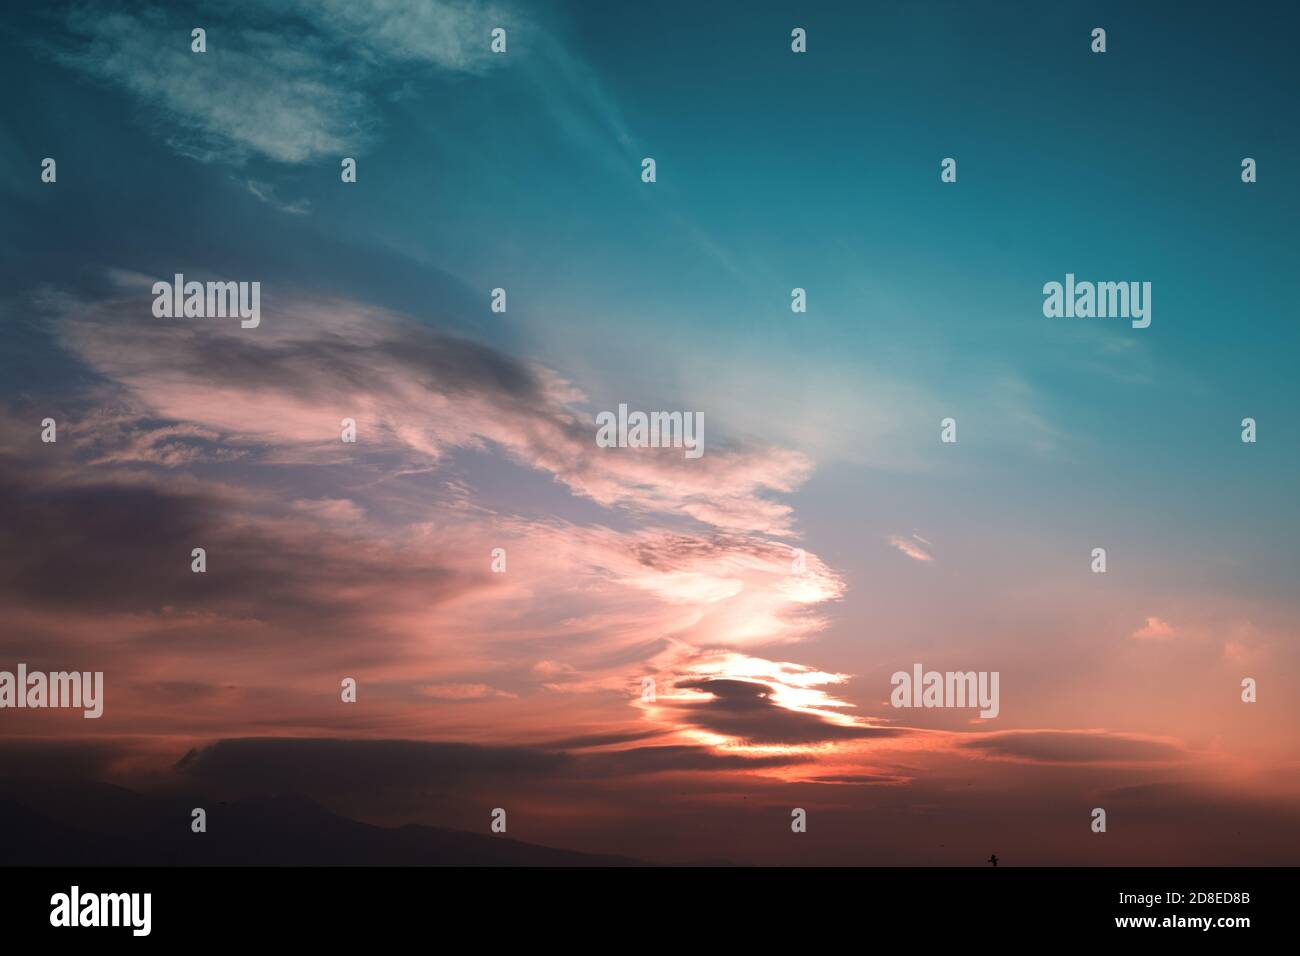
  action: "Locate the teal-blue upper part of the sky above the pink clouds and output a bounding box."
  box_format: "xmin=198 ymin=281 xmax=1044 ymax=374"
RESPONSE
xmin=0 ymin=4 xmax=1297 ymax=634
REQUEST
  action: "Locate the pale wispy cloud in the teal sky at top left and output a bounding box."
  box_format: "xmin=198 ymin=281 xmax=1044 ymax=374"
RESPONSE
xmin=56 ymin=0 xmax=508 ymax=164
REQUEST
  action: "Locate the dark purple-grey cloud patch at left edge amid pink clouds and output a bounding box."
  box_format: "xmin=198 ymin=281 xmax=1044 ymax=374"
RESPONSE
xmin=0 ymin=442 xmax=458 ymax=622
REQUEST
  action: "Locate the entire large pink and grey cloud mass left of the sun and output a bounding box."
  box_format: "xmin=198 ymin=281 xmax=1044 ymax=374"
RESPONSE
xmin=0 ymin=273 xmax=844 ymax=744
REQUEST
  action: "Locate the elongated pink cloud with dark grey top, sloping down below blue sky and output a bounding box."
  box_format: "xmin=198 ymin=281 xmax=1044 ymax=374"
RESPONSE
xmin=62 ymin=283 xmax=811 ymax=535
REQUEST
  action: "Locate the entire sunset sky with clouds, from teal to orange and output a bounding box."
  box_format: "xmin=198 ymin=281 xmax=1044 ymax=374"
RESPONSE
xmin=0 ymin=0 xmax=1300 ymax=865
